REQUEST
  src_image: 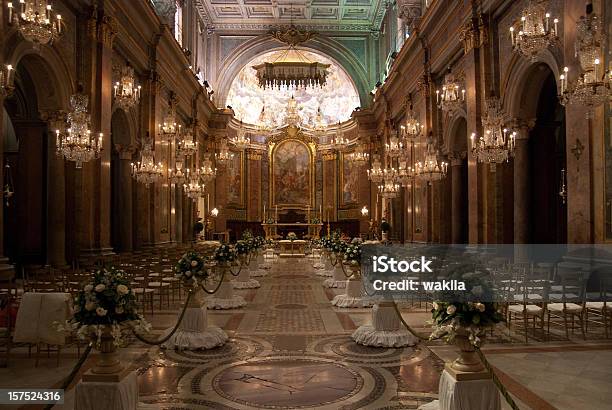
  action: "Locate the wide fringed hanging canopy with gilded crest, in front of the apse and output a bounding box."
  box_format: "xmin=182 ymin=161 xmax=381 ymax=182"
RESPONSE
xmin=253 ymin=25 xmax=330 ymax=89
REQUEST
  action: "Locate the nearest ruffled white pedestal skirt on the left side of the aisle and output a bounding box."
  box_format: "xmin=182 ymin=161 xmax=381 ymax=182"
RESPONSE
xmin=161 ymin=288 xmax=228 ymax=351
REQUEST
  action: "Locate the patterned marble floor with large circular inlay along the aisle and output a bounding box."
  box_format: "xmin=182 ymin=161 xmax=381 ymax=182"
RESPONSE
xmin=0 ymin=259 xmax=612 ymax=410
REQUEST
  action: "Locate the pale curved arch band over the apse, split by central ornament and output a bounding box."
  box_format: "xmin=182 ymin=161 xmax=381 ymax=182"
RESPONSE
xmin=216 ymin=36 xmax=368 ymax=107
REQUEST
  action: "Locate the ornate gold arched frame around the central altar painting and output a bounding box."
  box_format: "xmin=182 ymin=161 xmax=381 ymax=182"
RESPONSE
xmin=268 ymin=127 xmax=317 ymax=209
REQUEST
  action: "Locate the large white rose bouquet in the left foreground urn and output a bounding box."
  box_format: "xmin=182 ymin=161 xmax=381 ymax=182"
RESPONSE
xmin=58 ymin=267 xmax=151 ymax=346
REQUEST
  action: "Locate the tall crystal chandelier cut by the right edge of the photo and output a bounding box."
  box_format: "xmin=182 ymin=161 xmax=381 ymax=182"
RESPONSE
xmin=559 ymin=4 xmax=612 ymax=118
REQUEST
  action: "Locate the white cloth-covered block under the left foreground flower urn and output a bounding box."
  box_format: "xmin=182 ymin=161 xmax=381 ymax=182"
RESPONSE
xmin=75 ymin=371 xmax=138 ymax=410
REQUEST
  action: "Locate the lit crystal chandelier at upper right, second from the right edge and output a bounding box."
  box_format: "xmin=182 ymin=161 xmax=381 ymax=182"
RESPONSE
xmin=510 ymin=0 xmax=559 ymax=61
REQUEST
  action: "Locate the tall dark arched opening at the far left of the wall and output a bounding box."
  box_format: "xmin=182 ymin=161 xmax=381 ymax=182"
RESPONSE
xmin=2 ymin=54 xmax=67 ymax=268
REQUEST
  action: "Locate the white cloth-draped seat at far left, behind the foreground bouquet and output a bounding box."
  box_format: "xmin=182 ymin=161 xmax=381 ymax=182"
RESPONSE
xmin=13 ymin=292 xmax=72 ymax=346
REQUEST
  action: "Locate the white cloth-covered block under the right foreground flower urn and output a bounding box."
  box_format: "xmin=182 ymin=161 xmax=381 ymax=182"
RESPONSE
xmin=419 ymin=369 xmax=501 ymax=410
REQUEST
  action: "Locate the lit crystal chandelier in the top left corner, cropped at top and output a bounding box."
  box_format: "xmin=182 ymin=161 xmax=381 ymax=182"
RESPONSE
xmin=7 ymin=0 xmax=63 ymax=49
